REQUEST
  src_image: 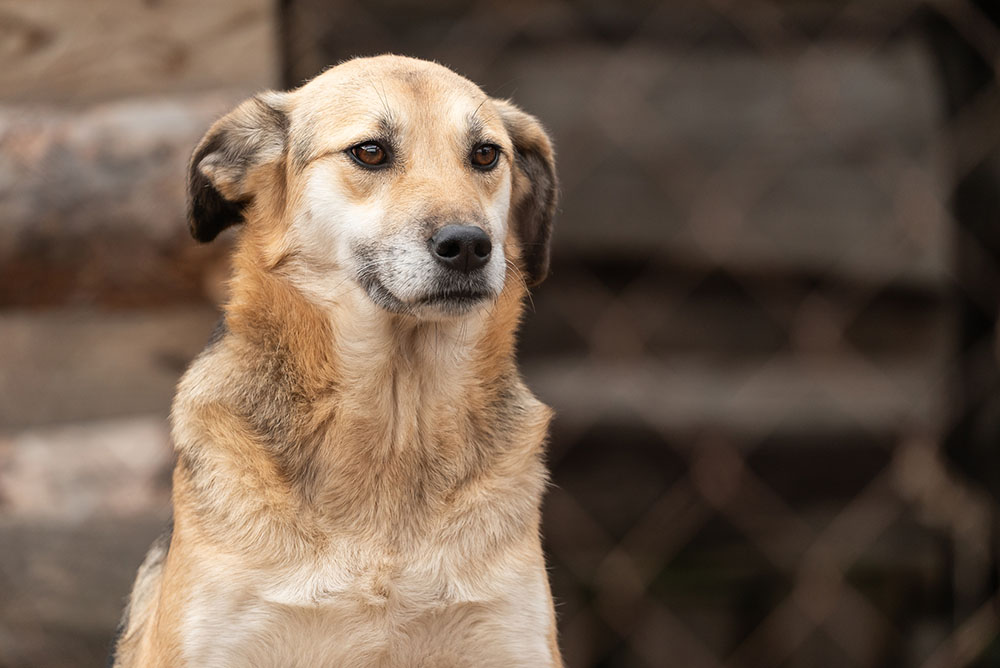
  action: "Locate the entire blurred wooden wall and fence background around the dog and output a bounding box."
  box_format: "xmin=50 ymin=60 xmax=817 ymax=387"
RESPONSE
xmin=0 ymin=0 xmax=1000 ymax=668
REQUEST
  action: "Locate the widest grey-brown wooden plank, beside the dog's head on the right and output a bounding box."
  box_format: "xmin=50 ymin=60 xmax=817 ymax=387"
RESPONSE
xmin=498 ymin=41 xmax=950 ymax=285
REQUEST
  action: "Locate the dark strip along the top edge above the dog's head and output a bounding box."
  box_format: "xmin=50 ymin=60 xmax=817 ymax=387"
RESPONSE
xmin=281 ymin=0 xmax=926 ymax=83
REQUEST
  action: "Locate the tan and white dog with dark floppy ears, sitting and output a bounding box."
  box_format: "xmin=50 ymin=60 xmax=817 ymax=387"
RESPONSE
xmin=110 ymin=56 xmax=562 ymax=668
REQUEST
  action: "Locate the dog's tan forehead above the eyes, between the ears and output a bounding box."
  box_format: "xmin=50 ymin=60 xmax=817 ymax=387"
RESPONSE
xmin=292 ymin=56 xmax=503 ymax=157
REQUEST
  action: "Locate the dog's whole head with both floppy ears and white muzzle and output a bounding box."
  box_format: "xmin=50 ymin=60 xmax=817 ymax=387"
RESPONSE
xmin=188 ymin=56 xmax=556 ymax=318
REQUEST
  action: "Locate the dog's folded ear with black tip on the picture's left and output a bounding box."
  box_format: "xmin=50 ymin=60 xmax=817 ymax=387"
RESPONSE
xmin=188 ymin=91 xmax=288 ymax=242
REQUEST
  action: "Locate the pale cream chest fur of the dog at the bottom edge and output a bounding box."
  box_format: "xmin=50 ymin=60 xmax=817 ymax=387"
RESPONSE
xmin=182 ymin=549 xmax=553 ymax=668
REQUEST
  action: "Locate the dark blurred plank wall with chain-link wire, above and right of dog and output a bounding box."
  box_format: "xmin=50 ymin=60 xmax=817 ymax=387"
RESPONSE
xmin=281 ymin=0 xmax=1000 ymax=668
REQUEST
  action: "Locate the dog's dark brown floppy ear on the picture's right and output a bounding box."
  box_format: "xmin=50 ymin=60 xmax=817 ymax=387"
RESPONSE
xmin=494 ymin=100 xmax=559 ymax=287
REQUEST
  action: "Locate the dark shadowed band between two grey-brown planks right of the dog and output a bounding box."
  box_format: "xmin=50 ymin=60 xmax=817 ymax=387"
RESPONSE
xmin=519 ymin=262 xmax=957 ymax=369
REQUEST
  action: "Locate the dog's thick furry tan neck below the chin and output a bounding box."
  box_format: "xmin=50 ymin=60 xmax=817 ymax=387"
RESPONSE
xmin=208 ymin=254 xmax=536 ymax=532
